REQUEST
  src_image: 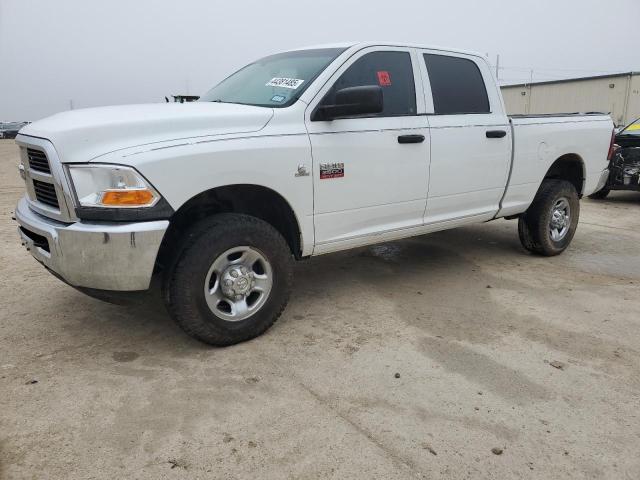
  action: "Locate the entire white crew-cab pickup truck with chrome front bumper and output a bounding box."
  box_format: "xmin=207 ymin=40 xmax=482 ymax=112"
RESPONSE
xmin=15 ymin=43 xmax=613 ymax=345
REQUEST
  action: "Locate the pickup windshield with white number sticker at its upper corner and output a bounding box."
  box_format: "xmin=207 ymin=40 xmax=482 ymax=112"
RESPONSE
xmin=199 ymin=48 xmax=344 ymax=108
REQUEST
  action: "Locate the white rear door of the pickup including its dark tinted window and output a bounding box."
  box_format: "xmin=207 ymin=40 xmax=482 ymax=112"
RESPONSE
xmin=420 ymin=50 xmax=511 ymax=224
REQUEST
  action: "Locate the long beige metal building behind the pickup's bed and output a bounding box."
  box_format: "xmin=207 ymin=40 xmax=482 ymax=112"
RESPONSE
xmin=502 ymin=72 xmax=640 ymax=125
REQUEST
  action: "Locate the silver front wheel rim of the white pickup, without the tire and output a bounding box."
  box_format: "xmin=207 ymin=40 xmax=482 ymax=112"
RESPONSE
xmin=204 ymin=247 xmax=273 ymax=322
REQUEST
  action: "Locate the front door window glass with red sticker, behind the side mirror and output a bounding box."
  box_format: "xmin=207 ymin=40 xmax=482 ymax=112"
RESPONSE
xmin=322 ymin=51 xmax=416 ymax=117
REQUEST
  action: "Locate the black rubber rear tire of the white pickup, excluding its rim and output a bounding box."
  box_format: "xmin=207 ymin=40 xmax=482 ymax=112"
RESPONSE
xmin=518 ymin=179 xmax=580 ymax=257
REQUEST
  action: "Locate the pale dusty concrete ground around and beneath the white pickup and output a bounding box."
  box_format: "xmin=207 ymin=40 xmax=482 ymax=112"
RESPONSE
xmin=0 ymin=140 xmax=640 ymax=480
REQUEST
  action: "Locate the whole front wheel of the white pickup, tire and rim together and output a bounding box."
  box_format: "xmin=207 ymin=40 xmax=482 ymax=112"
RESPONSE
xmin=164 ymin=213 xmax=293 ymax=346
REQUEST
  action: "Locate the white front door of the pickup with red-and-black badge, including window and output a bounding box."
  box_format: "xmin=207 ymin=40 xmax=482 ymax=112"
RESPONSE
xmin=306 ymin=47 xmax=429 ymax=253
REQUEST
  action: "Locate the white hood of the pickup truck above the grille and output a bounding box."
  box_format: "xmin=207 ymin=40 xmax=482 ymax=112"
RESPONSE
xmin=20 ymin=102 xmax=273 ymax=163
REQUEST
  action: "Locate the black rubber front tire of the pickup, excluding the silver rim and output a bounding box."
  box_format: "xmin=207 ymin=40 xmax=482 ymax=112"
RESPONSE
xmin=163 ymin=213 xmax=293 ymax=346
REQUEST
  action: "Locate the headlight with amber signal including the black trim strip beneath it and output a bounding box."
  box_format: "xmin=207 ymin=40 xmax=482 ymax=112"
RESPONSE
xmin=66 ymin=164 xmax=174 ymax=222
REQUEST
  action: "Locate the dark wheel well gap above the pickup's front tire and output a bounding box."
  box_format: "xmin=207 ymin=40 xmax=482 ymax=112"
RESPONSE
xmin=156 ymin=184 xmax=302 ymax=268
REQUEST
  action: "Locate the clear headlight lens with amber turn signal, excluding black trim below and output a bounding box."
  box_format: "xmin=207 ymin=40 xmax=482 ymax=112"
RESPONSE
xmin=67 ymin=165 xmax=160 ymax=208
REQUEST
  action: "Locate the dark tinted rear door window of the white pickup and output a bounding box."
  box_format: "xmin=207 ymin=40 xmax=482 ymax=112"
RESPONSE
xmin=424 ymin=54 xmax=491 ymax=115
